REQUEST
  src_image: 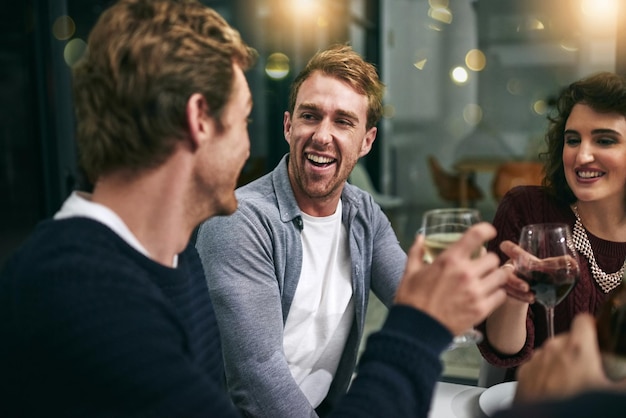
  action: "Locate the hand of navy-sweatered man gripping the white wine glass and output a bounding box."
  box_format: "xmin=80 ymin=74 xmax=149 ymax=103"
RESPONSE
xmin=395 ymin=222 xmax=508 ymax=335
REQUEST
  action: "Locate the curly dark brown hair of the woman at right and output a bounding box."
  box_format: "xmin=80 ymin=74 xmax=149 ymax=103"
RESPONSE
xmin=541 ymin=72 xmax=626 ymax=204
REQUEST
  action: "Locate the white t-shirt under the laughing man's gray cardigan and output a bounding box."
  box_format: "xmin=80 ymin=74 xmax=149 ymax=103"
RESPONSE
xmin=283 ymin=201 xmax=354 ymax=408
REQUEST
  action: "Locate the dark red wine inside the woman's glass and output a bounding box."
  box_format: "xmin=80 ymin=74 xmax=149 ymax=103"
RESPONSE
xmin=516 ymin=269 xmax=578 ymax=307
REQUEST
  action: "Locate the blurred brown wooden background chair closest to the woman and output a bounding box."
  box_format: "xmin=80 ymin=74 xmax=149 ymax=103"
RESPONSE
xmin=491 ymin=161 xmax=544 ymax=202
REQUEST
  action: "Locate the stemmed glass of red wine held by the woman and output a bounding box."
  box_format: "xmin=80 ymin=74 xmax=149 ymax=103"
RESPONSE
xmin=513 ymin=223 xmax=580 ymax=338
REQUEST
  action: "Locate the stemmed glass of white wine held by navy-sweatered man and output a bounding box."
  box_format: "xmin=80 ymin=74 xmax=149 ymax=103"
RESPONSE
xmin=420 ymin=208 xmax=483 ymax=349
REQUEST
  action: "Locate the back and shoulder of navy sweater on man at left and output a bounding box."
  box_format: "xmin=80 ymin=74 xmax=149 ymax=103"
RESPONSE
xmin=0 ymin=218 xmax=234 ymax=417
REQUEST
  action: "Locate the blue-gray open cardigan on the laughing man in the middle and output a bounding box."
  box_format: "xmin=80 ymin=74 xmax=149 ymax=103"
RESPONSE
xmin=196 ymin=155 xmax=406 ymax=418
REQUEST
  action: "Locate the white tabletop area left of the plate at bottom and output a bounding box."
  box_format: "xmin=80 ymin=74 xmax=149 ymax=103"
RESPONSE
xmin=428 ymin=382 xmax=486 ymax=418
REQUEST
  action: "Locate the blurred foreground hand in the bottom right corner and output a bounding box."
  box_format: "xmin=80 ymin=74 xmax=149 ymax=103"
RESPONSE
xmin=514 ymin=313 xmax=626 ymax=403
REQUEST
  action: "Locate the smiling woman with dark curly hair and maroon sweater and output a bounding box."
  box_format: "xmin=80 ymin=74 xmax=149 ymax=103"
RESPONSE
xmin=479 ymin=72 xmax=626 ymax=380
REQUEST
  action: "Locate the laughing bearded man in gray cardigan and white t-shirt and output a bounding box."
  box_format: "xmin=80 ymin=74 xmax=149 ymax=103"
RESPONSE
xmin=197 ymin=46 xmax=406 ymax=417
